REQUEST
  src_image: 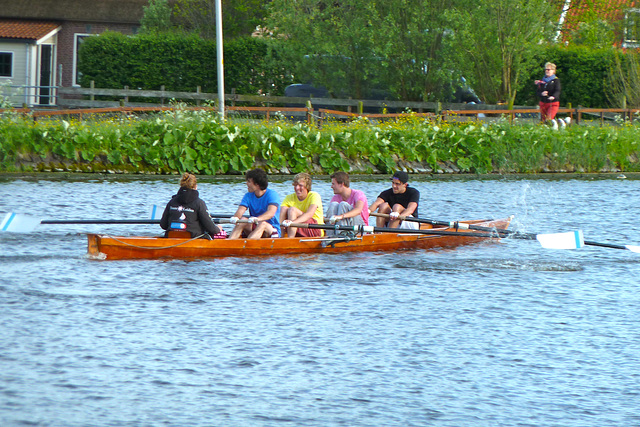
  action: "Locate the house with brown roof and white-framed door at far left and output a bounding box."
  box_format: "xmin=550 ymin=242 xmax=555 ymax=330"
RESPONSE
xmin=0 ymin=0 xmax=172 ymax=106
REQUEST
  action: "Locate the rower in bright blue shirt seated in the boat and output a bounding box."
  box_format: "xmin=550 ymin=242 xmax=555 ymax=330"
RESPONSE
xmin=229 ymin=169 xmax=281 ymax=239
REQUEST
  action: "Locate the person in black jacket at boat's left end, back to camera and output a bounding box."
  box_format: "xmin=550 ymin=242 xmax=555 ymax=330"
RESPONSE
xmin=160 ymin=173 xmax=220 ymax=238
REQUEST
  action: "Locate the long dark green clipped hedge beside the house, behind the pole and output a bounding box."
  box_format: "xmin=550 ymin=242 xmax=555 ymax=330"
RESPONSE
xmin=78 ymin=32 xmax=292 ymax=95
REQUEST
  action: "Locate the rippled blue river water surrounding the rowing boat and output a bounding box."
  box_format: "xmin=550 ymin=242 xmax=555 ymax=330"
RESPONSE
xmin=0 ymin=175 xmax=640 ymax=426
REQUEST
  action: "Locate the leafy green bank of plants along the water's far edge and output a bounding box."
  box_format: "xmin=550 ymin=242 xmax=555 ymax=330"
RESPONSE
xmin=0 ymin=110 xmax=640 ymax=175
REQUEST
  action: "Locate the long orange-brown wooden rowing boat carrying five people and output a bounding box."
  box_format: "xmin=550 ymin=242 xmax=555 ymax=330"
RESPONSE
xmin=87 ymin=218 xmax=511 ymax=260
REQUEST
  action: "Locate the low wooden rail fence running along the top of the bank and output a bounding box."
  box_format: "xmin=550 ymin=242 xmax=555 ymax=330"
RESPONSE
xmin=0 ymin=87 xmax=640 ymax=126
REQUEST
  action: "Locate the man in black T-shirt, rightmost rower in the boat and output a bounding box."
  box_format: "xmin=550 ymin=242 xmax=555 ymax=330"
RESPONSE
xmin=369 ymin=171 xmax=420 ymax=229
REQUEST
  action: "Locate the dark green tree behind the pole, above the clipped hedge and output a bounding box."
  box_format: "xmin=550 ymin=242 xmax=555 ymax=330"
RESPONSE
xmin=174 ymin=0 xmax=269 ymax=39
